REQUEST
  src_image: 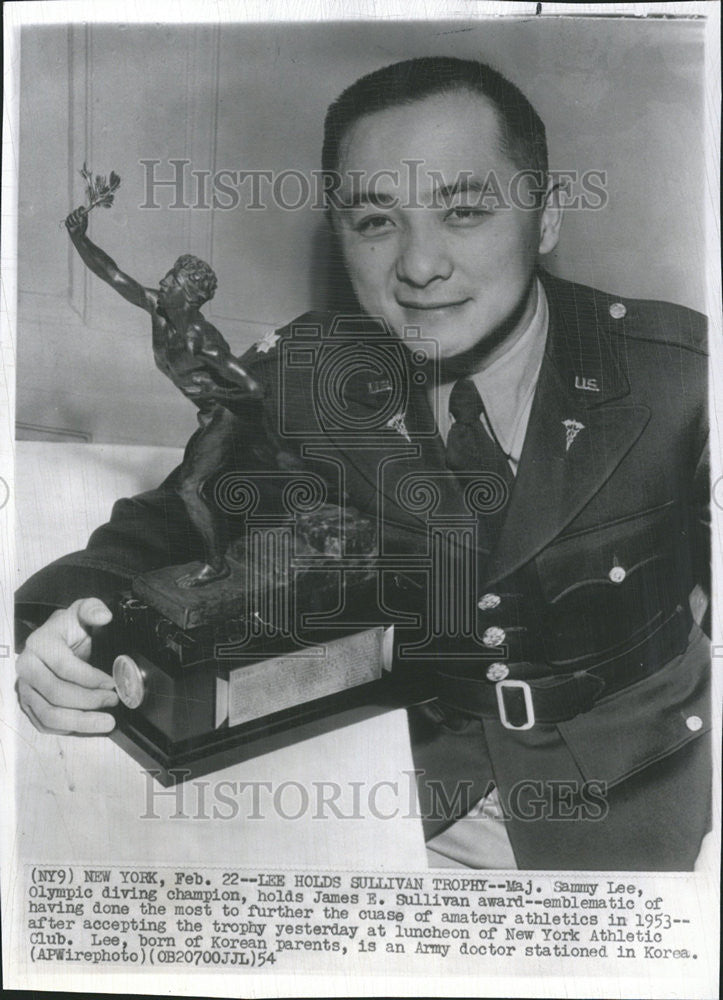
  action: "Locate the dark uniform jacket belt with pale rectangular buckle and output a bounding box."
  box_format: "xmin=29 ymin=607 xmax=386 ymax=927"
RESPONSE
xmin=436 ymin=607 xmax=692 ymax=730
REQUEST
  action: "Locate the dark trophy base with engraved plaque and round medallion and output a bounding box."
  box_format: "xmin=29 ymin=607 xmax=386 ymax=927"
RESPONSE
xmin=93 ymin=564 xmax=425 ymax=786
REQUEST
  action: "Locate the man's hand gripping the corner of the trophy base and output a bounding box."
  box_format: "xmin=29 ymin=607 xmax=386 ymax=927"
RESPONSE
xmin=17 ymin=597 xmax=118 ymax=733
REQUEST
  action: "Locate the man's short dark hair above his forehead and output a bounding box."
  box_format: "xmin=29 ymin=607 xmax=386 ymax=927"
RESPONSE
xmin=321 ymin=56 xmax=547 ymax=181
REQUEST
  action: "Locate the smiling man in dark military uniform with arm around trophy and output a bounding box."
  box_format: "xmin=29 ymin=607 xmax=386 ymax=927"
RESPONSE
xmin=18 ymin=58 xmax=710 ymax=870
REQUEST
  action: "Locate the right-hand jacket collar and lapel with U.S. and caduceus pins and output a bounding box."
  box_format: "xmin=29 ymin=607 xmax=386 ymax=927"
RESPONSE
xmin=487 ymin=273 xmax=650 ymax=581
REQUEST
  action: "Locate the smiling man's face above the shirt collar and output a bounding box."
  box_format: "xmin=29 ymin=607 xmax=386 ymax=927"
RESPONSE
xmin=334 ymin=92 xmax=559 ymax=358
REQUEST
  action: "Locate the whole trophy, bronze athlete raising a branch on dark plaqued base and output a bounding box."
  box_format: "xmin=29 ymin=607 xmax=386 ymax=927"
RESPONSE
xmin=65 ymin=165 xmax=419 ymax=785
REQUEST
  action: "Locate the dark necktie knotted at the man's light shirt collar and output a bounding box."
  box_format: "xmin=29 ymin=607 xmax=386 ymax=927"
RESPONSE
xmin=447 ymin=378 xmax=514 ymax=533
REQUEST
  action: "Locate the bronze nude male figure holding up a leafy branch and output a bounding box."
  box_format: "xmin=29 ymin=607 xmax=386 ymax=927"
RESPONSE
xmin=65 ymin=201 xmax=262 ymax=587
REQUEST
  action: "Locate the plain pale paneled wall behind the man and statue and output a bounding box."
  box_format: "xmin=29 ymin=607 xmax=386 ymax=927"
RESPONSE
xmin=17 ymin=17 xmax=705 ymax=445
